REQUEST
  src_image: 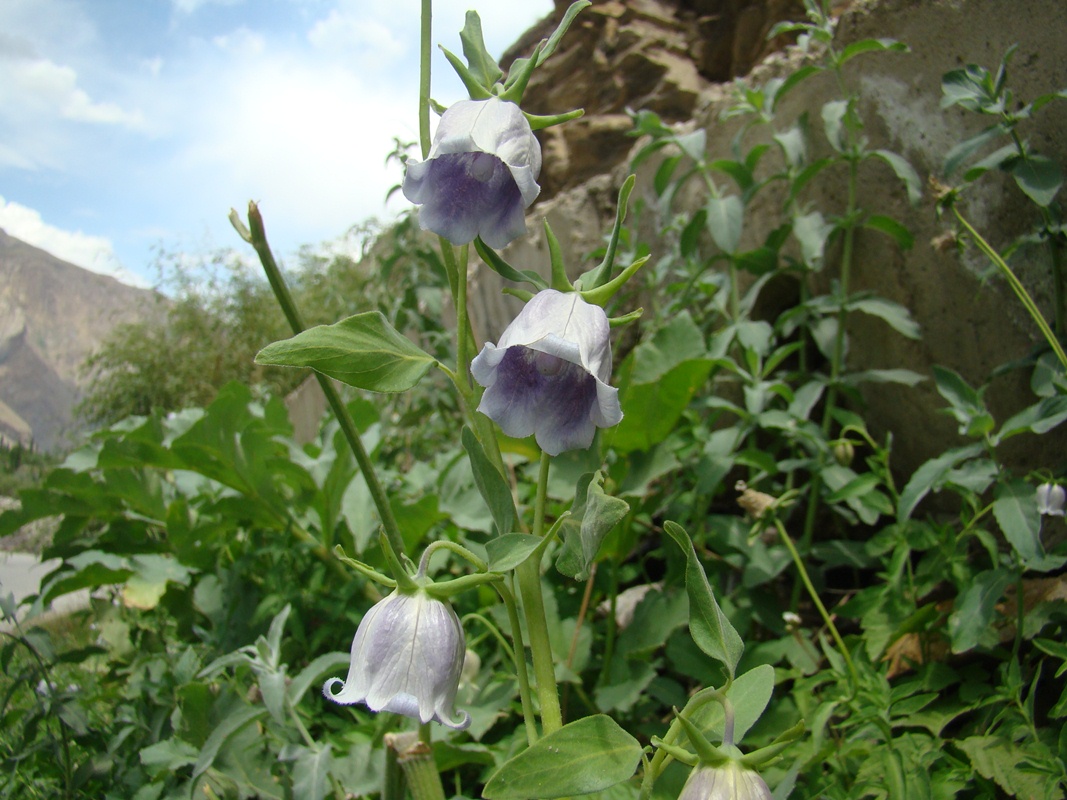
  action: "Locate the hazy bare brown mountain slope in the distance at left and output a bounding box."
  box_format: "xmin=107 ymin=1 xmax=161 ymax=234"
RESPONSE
xmin=0 ymin=229 xmax=160 ymax=450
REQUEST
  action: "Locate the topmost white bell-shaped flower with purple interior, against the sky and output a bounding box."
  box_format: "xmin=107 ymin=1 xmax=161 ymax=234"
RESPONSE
xmin=403 ymin=97 xmax=541 ymax=249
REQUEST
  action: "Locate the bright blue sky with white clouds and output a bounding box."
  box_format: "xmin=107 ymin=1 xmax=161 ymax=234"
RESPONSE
xmin=0 ymin=0 xmax=553 ymax=286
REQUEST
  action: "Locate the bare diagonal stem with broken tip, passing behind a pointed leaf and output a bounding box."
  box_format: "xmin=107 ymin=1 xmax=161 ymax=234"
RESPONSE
xmin=248 ymin=203 xmax=404 ymax=555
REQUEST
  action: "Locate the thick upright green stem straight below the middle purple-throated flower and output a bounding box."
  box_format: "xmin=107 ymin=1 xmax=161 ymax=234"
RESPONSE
xmin=515 ymin=453 xmax=563 ymax=734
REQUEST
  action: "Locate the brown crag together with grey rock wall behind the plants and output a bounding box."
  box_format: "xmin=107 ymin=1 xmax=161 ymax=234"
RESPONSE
xmin=471 ymin=0 xmax=1067 ymax=473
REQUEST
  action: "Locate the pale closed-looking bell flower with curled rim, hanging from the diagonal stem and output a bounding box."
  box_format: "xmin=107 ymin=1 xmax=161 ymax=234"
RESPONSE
xmin=322 ymin=590 xmax=471 ymax=730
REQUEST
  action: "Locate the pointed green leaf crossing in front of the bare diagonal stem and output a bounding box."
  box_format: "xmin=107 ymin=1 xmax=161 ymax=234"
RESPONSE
xmin=256 ymin=311 xmax=435 ymax=393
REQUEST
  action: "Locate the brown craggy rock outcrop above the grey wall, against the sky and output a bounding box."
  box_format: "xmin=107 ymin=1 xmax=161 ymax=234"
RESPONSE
xmin=501 ymin=0 xmax=803 ymax=199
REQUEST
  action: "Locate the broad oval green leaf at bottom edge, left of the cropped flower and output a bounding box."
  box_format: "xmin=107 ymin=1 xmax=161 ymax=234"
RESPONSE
xmin=482 ymin=714 xmax=641 ymax=800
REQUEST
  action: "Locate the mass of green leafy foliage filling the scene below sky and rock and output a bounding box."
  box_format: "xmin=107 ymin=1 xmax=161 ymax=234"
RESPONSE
xmin=6 ymin=0 xmax=1067 ymax=800
